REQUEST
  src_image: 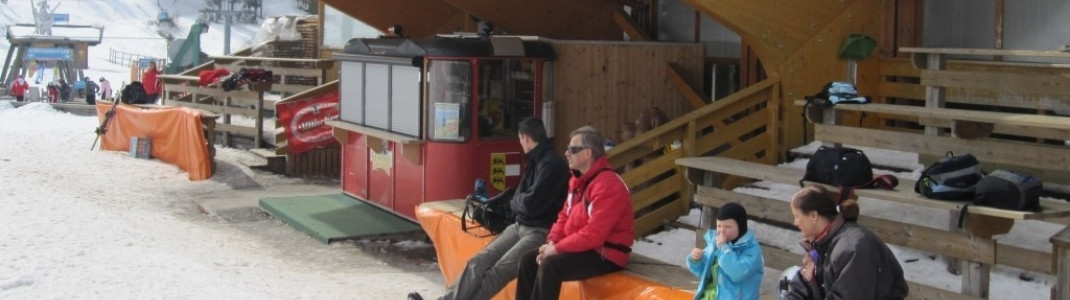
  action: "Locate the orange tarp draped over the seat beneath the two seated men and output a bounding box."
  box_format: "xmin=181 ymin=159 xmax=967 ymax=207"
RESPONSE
xmin=416 ymin=203 xmax=694 ymax=300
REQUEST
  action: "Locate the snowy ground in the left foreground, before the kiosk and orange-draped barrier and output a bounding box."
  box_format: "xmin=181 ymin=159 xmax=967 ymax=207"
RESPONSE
xmin=0 ymin=101 xmax=444 ymax=299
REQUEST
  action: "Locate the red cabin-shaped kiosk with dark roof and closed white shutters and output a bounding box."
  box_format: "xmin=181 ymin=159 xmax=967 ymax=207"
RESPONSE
xmin=330 ymin=35 xmax=554 ymax=219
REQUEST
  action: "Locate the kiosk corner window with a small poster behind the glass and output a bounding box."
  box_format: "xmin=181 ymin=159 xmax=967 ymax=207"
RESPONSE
xmin=427 ymin=60 xmax=472 ymax=141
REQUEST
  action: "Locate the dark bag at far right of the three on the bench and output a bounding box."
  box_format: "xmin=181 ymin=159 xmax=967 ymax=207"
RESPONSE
xmin=974 ymin=170 xmax=1044 ymax=211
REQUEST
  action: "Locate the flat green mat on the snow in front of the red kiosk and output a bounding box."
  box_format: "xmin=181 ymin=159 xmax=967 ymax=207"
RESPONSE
xmin=260 ymin=194 xmax=422 ymax=243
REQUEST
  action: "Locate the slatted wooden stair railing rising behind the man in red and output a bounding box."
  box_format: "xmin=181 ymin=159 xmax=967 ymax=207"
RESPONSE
xmin=607 ymin=78 xmax=781 ymax=236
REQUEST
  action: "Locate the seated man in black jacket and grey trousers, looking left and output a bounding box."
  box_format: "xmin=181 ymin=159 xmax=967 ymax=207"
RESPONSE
xmin=409 ymin=118 xmax=568 ymax=300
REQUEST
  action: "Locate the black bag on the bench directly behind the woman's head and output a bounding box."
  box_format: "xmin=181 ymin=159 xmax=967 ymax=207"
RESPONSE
xmin=799 ymin=146 xmax=873 ymax=188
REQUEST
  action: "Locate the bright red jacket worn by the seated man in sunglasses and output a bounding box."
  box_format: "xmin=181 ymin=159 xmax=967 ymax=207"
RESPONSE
xmin=547 ymin=158 xmax=635 ymax=267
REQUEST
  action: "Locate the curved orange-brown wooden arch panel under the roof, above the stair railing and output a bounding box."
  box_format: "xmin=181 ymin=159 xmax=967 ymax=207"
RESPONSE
xmin=682 ymin=0 xmax=885 ymax=153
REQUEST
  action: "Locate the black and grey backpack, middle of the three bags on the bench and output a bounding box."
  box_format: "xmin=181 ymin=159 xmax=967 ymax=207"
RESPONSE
xmin=914 ymin=152 xmax=984 ymax=200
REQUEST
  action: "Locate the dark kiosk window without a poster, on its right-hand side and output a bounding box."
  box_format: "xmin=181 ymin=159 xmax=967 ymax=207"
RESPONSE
xmin=477 ymin=59 xmax=535 ymax=139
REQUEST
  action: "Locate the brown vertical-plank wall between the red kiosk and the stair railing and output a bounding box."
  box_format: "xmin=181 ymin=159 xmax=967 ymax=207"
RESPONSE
xmin=551 ymin=41 xmax=705 ymax=149
